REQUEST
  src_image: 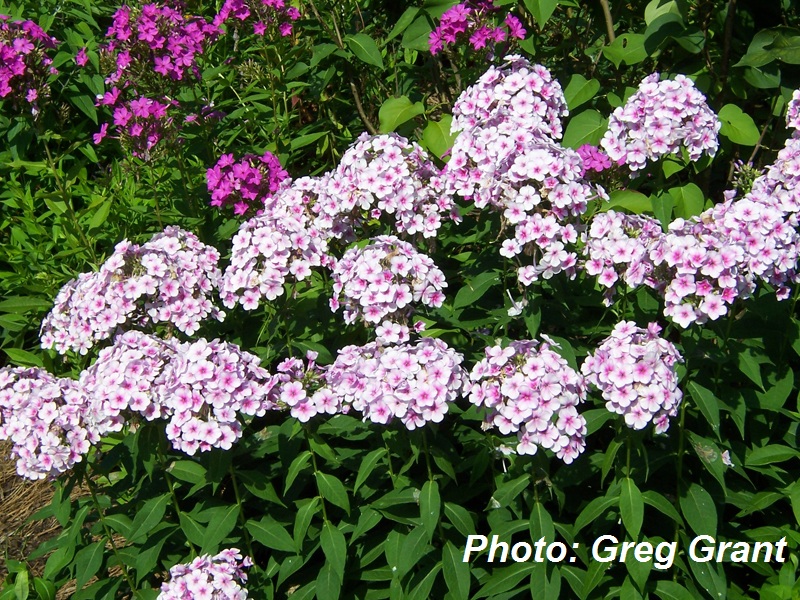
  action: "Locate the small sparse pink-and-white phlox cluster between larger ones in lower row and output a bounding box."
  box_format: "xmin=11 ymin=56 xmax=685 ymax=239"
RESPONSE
xmin=269 ymin=350 xmax=340 ymax=423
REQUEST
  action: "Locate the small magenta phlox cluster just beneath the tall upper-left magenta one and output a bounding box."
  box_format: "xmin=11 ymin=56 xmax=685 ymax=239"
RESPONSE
xmin=92 ymin=88 xmax=178 ymax=161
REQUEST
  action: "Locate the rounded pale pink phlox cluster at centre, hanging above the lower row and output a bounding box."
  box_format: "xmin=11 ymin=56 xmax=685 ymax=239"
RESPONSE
xmin=330 ymin=235 xmax=447 ymax=323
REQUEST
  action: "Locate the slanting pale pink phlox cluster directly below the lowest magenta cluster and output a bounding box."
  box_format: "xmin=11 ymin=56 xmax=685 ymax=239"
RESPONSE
xmin=220 ymin=186 xmax=332 ymax=310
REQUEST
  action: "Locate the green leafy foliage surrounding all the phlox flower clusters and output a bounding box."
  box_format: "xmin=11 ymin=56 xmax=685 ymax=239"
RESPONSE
xmin=0 ymin=0 xmax=800 ymax=599
